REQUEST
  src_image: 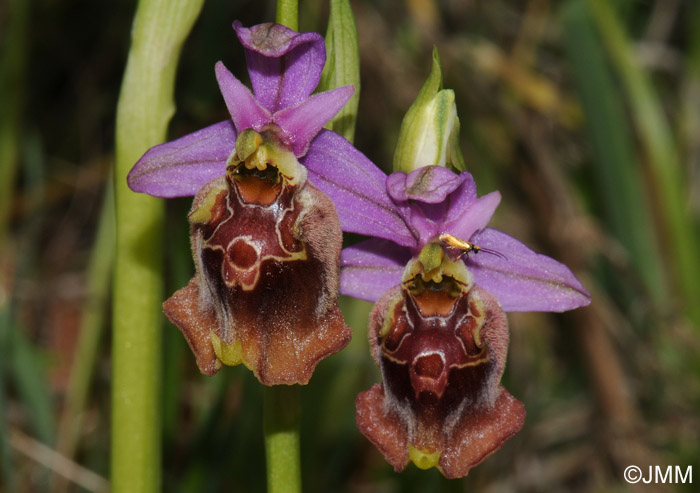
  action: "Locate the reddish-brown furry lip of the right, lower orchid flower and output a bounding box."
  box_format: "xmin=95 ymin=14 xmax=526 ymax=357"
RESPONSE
xmin=356 ymin=247 xmax=525 ymax=478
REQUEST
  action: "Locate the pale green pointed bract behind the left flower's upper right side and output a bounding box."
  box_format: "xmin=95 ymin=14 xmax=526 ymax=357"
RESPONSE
xmin=318 ymin=0 xmax=360 ymax=142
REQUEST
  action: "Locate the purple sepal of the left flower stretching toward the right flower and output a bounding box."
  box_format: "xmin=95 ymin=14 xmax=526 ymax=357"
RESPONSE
xmin=301 ymin=130 xmax=416 ymax=247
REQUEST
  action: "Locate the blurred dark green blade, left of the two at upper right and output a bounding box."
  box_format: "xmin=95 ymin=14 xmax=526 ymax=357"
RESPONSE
xmin=563 ymin=0 xmax=668 ymax=304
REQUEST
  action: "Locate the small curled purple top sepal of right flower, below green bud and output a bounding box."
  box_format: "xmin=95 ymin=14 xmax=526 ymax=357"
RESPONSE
xmin=386 ymin=166 xmax=476 ymax=204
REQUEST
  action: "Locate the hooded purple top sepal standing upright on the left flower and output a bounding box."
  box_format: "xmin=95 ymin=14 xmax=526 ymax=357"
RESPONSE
xmin=233 ymin=21 xmax=326 ymax=113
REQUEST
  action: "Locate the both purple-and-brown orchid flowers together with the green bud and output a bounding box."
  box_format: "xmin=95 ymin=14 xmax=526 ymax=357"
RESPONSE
xmin=128 ymin=22 xmax=590 ymax=478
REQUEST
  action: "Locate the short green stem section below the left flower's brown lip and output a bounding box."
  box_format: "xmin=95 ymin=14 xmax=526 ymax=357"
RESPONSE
xmin=263 ymin=385 xmax=301 ymax=493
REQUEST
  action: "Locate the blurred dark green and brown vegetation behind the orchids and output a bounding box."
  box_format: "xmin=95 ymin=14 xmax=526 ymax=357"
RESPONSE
xmin=0 ymin=0 xmax=700 ymax=492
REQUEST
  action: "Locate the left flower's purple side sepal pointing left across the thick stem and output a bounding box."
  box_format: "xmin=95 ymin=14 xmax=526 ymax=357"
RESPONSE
xmin=126 ymin=120 xmax=236 ymax=198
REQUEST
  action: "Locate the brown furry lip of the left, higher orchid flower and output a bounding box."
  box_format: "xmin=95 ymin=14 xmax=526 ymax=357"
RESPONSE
xmin=163 ymin=130 xmax=351 ymax=385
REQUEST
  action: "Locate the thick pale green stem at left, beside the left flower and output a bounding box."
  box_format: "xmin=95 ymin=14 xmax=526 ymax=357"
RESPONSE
xmin=111 ymin=0 xmax=203 ymax=493
